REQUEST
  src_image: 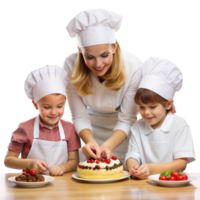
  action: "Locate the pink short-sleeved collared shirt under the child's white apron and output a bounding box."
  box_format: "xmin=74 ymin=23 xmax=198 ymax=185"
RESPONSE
xmin=7 ymin=116 xmax=81 ymax=158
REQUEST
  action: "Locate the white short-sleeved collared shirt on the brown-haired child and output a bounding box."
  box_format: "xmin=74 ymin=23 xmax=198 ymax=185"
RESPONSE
xmin=125 ymin=112 xmax=196 ymax=164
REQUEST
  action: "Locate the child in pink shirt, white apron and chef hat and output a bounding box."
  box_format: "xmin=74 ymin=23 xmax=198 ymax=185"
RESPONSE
xmin=4 ymin=65 xmax=81 ymax=175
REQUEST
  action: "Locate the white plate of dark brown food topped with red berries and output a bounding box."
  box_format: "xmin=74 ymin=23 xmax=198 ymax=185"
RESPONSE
xmin=8 ymin=167 xmax=55 ymax=187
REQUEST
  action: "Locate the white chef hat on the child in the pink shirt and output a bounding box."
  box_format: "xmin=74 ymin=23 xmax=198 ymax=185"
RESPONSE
xmin=24 ymin=64 xmax=68 ymax=103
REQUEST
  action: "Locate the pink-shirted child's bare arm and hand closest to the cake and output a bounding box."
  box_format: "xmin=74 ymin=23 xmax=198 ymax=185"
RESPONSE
xmin=59 ymin=149 xmax=79 ymax=173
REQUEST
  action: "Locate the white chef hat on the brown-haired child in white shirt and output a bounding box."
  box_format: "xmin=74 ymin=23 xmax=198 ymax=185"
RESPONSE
xmin=139 ymin=57 xmax=183 ymax=100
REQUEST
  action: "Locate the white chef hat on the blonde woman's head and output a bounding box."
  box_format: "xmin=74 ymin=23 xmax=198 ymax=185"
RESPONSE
xmin=65 ymin=8 xmax=123 ymax=48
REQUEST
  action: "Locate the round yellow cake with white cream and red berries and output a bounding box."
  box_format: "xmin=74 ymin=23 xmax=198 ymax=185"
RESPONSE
xmin=77 ymin=156 xmax=124 ymax=179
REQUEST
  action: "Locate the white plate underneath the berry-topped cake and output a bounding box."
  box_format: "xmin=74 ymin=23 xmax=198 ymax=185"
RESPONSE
xmin=72 ymin=171 xmax=130 ymax=183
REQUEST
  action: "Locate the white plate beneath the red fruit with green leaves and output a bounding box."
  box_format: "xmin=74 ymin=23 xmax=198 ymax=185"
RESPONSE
xmin=148 ymin=173 xmax=197 ymax=187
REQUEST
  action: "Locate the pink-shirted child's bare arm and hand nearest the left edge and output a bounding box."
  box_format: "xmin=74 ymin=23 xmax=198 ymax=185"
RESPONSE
xmin=3 ymin=150 xmax=49 ymax=173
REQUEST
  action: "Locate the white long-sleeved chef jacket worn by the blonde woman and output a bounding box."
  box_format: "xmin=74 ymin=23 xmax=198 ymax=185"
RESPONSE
xmin=63 ymin=49 xmax=143 ymax=135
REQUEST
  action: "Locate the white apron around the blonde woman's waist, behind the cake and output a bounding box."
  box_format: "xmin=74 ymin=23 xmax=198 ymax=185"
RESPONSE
xmin=79 ymin=107 xmax=130 ymax=162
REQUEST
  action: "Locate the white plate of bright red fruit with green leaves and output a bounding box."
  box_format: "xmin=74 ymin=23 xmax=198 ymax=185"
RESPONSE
xmin=148 ymin=170 xmax=197 ymax=187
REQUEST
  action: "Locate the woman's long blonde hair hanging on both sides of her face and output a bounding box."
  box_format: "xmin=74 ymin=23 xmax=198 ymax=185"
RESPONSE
xmin=71 ymin=41 xmax=125 ymax=97
